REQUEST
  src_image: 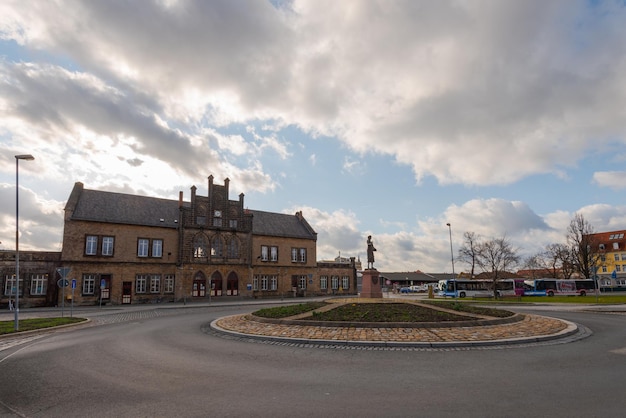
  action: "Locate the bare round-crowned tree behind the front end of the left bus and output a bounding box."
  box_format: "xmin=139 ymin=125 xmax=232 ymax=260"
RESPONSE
xmin=476 ymin=237 xmax=519 ymax=297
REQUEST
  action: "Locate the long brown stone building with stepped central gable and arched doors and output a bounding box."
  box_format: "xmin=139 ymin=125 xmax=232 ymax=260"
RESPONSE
xmin=60 ymin=176 xmax=357 ymax=304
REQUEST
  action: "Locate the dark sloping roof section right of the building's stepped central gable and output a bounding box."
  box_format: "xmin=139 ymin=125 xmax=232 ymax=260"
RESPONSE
xmin=250 ymin=210 xmax=317 ymax=240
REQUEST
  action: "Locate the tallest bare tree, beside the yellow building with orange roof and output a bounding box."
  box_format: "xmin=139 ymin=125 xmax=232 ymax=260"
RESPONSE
xmin=567 ymin=213 xmax=600 ymax=279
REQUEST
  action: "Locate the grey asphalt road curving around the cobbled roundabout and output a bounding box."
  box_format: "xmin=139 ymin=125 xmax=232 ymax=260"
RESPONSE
xmin=0 ymin=305 xmax=626 ymax=418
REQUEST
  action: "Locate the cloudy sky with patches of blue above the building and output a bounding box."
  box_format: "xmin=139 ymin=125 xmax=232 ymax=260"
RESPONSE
xmin=0 ymin=0 xmax=626 ymax=273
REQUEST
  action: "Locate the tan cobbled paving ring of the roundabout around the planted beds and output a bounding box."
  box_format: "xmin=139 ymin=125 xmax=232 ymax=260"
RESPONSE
xmin=211 ymin=299 xmax=591 ymax=348
